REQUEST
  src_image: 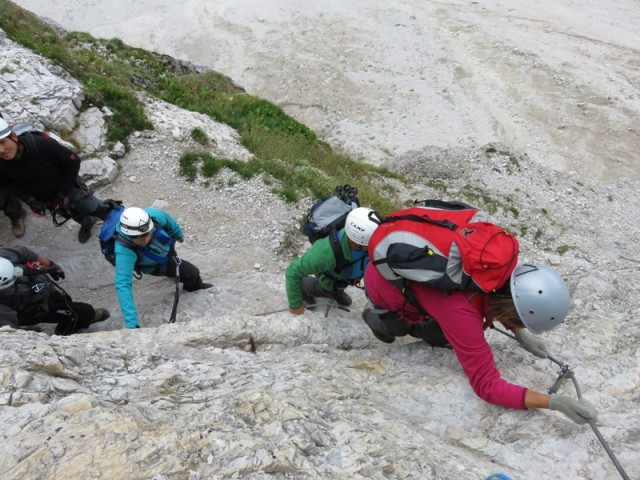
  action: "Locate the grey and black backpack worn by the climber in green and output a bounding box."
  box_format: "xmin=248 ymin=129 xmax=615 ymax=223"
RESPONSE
xmin=302 ymin=185 xmax=360 ymax=273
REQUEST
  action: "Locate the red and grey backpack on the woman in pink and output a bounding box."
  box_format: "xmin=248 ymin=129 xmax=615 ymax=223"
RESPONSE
xmin=369 ymin=200 xmax=519 ymax=292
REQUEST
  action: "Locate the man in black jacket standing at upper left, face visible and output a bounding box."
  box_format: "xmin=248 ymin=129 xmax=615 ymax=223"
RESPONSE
xmin=0 ymin=118 xmax=112 ymax=243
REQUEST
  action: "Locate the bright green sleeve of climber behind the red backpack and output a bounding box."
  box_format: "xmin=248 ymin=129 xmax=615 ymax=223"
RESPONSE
xmin=285 ymin=238 xmax=336 ymax=309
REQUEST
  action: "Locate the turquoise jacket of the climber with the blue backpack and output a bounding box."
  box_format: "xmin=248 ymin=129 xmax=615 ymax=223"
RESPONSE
xmin=114 ymin=208 xmax=184 ymax=328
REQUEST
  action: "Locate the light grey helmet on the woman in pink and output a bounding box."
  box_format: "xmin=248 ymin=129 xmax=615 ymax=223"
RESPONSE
xmin=511 ymin=263 xmax=570 ymax=334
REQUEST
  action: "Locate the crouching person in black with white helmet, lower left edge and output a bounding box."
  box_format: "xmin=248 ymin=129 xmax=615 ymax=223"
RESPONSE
xmin=0 ymin=247 xmax=109 ymax=335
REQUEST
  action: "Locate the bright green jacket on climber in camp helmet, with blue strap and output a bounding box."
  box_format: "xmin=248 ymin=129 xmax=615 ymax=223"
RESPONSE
xmin=285 ymin=228 xmax=369 ymax=309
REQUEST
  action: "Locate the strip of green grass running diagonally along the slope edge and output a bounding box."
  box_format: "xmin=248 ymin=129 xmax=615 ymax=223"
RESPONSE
xmin=0 ymin=0 xmax=401 ymax=212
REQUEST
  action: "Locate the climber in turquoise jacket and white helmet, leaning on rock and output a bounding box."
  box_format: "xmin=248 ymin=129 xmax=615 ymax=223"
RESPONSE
xmin=115 ymin=207 xmax=213 ymax=328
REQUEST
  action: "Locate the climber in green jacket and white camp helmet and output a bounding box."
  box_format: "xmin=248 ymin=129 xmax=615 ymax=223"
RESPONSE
xmin=285 ymin=207 xmax=378 ymax=315
